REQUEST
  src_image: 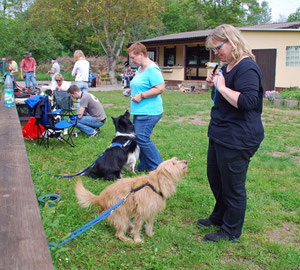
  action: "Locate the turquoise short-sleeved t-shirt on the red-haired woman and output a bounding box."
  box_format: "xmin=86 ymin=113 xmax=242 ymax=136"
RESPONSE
xmin=130 ymin=63 xmax=164 ymax=115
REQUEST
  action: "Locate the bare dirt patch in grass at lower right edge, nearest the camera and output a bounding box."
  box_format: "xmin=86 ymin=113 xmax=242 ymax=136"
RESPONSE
xmin=266 ymin=222 xmax=299 ymax=247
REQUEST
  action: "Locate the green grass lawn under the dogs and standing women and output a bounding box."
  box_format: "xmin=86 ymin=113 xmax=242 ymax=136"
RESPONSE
xmin=26 ymin=91 xmax=300 ymax=269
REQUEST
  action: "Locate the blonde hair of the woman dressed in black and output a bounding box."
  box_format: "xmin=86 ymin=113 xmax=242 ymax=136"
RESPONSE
xmin=205 ymin=24 xmax=255 ymax=61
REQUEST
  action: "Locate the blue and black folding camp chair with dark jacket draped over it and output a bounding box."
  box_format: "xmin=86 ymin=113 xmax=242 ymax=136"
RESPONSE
xmin=26 ymin=96 xmax=77 ymax=149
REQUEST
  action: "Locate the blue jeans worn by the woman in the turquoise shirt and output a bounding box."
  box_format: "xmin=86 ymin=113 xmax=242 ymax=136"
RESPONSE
xmin=133 ymin=114 xmax=162 ymax=171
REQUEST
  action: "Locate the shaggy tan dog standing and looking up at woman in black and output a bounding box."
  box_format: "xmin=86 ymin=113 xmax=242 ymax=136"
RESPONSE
xmin=75 ymin=158 xmax=187 ymax=243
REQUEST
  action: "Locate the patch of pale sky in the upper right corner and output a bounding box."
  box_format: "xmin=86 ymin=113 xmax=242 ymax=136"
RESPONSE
xmin=259 ymin=0 xmax=300 ymax=22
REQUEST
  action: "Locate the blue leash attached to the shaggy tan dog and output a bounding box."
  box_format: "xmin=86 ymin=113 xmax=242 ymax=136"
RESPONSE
xmin=48 ymin=196 xmax=125 ymax=250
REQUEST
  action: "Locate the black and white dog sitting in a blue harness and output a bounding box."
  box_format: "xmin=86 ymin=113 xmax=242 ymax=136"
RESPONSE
xmin=85 ymin=111 xmax=140 ymax=180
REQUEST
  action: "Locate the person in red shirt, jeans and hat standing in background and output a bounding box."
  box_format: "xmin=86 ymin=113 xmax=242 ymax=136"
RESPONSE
xmin=20 ymin=52 xmax=37 ymax=89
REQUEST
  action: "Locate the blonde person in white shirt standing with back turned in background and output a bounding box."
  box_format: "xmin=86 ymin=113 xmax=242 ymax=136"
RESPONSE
xmin=72 ymin=50 xmax=90 ymax=92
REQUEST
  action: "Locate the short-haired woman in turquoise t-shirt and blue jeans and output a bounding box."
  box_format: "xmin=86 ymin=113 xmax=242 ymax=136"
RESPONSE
xmin=127 ymin=42 xmax=165 ymax=171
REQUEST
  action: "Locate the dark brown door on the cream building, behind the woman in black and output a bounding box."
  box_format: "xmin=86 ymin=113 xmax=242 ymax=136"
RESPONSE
xmin=252 ymin=49 xmax=277 ymax=91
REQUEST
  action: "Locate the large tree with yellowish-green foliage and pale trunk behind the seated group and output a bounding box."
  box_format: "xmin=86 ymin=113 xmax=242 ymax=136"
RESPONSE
xmin=32 ymin=0 xmax=164 ymax=82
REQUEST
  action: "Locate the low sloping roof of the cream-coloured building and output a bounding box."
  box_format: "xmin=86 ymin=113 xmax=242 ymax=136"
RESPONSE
xmin=139 ymin=21 xmax=300 ymax=45
